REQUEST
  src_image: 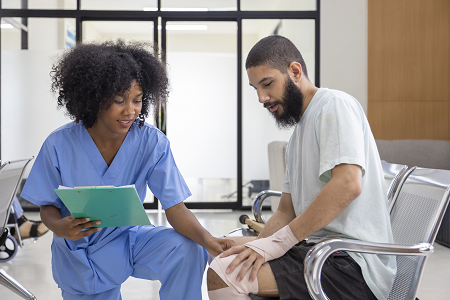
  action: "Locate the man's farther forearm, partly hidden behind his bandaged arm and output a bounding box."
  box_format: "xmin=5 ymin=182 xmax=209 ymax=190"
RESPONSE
xmin=258 ymin=193 xmax=295 ymax=238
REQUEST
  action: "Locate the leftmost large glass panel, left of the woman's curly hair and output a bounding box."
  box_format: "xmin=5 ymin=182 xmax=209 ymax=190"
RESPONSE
xmin=1 ymin=18 xmax=75 ymax=206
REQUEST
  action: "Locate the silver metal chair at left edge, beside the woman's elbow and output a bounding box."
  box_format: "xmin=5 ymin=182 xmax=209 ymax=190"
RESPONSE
xmin=0 ymin=158 xmax=36 ymax=299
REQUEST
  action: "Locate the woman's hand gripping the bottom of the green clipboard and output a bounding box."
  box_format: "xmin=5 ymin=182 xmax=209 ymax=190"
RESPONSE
xmin=53 ymin=216 xmax=101 ymax=241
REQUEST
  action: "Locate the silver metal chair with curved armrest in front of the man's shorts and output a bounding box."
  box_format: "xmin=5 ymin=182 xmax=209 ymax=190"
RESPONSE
xmin=304 ymin=167 xmax=450 ymax=300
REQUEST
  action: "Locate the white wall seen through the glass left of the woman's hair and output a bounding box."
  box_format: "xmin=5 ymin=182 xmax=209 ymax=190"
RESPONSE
xmin=1 ymin=50 xmax=69 ymax=165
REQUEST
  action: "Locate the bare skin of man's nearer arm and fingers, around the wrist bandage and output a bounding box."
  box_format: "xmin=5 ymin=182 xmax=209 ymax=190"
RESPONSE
xmin=221 ymin=164 xmax=362 ymax=282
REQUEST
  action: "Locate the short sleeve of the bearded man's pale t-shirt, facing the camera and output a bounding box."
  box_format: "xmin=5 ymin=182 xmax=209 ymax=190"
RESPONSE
xmin=315 ymin=98 xmax=365 ymax=183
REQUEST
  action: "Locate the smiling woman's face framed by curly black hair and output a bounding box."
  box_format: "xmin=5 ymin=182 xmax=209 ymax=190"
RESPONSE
xmin=92 ymin=79 xmax=142 ymax=137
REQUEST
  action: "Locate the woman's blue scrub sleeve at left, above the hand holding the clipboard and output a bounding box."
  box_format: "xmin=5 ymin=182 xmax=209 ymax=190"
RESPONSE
xmin=20 ymin=139 xmax=63 ymax=209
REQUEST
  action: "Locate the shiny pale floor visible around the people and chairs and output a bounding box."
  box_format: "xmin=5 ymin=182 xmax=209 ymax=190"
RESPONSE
xmin=0 ymin=211 xmax=450 ymax=300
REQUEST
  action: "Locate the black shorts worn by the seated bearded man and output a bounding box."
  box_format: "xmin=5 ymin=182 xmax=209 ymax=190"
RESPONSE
xmin=269 ymin=241 xmax=377 ymax=300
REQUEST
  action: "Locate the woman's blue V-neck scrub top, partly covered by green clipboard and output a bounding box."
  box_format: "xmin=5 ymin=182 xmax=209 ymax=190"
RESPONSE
xmin=21 ymin=122 xmax=191 ymax=290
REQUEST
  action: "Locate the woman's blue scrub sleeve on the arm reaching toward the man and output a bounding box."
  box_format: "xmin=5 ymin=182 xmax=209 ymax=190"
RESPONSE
xmin=147 ymin=139 xmax=191 ymax=209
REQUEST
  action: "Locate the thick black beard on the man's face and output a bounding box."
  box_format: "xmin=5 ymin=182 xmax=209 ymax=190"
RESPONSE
xmin=264 ymin=77 xmax=304 ymax=129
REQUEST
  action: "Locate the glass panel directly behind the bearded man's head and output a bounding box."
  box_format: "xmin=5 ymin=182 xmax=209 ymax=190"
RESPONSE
xmin=242 ymin=20 xmax=315 ymax=205
